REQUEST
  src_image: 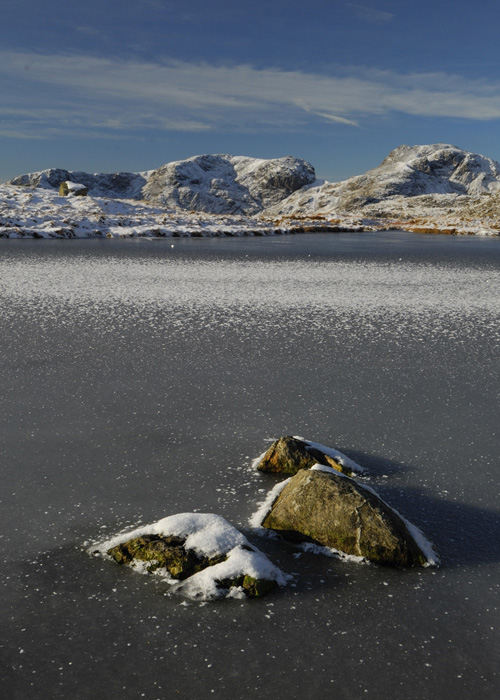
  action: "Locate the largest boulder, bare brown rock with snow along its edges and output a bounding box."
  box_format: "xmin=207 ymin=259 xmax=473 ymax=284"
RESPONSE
xmin=262 ymin=467 xmax=429 ymax=566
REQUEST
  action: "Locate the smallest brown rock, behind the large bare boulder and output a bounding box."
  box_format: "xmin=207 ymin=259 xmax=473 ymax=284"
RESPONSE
xmin=257 ymin=435 xmax=365 ymax=476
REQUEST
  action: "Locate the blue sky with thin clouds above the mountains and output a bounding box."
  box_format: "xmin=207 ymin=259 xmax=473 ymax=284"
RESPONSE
xmin=0 ymin=0 xmax=500 ymax=180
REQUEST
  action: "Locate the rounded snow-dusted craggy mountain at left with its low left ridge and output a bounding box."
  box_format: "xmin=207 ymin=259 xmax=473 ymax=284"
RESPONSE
xmin=9 ymin=155 xmax=315 ymax=215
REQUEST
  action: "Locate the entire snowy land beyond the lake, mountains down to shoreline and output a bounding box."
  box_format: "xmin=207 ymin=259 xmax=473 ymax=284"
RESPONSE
xmin=5 ymin=144 xmax=500 ymax=238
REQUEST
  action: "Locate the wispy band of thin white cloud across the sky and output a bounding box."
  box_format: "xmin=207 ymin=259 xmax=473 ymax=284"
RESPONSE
xmin=0 ymin=51 xmax=500 ymax=137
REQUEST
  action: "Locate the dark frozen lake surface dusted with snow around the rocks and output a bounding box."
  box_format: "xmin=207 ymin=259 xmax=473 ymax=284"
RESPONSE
xmin=0 ymin=233 xmax=500 ymax=700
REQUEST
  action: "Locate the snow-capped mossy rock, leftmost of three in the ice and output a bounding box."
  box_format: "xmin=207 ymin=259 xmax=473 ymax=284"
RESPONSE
xmin=87 ymin=513 xmax=289 ymax=600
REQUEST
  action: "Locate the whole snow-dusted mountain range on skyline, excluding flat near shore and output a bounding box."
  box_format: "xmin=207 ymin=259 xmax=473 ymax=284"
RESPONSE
xmin=8 ymin=143 xmax=500 ymax=226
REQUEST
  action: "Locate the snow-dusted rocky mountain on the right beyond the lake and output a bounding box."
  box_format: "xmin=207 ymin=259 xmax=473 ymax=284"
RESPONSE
xmin=270 ymin=143 xmax=500 ymax=214
